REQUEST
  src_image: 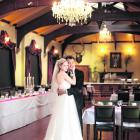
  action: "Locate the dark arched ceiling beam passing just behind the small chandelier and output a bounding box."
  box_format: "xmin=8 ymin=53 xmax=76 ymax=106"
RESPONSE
xmin=44 ymin=25 xmax=140 ymax=50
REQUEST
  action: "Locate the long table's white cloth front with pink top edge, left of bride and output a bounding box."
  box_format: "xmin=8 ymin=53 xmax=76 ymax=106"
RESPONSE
xmin=0 ymin=93 xmax=53 ymax=135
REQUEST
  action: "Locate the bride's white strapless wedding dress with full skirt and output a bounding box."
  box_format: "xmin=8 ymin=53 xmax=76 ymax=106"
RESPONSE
xmin=44 ymin=81 xmax=83 ymax=140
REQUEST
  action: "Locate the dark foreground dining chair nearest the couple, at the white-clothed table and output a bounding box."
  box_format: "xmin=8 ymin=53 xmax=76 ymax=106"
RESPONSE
xmin=94 ymin=105 xmax=116 ymax=140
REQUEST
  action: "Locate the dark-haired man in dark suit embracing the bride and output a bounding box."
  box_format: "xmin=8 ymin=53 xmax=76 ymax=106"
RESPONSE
xmin=65 ymin=56 xmax=84 ymax=130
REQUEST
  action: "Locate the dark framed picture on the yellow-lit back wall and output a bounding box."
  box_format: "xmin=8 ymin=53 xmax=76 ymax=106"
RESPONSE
xmin=110 ymin=52 xmax=122 ymax=68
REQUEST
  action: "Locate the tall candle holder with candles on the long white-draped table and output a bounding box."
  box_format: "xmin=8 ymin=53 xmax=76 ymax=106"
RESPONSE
xmin=25 ymin=73 xmax=34 ymax=95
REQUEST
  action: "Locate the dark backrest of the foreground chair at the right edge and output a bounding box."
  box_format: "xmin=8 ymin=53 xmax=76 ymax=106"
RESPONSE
xmin=121 ymin=106 xmax=140 ymax=123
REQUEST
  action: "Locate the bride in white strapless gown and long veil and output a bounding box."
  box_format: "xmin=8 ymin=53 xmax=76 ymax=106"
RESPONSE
xmin=44 ymin=58 xmax=83 ymax=140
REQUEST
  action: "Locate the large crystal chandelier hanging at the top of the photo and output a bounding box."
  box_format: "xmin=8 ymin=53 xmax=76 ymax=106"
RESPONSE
xmin=52 ymin=0 xmax=92 ymax=26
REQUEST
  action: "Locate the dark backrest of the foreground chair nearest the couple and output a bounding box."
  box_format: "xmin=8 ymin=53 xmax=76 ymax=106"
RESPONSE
xmin=95 ymin=105 xmax=115 ymax=124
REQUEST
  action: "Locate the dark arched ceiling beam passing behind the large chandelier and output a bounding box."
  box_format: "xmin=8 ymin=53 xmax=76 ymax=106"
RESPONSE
xmin=17 ymin=11 xmax=140 ymax=46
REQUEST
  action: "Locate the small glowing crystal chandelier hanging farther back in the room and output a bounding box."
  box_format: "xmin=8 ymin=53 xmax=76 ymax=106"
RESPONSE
xmin=99 ymin=24 xmax=111 ymax=42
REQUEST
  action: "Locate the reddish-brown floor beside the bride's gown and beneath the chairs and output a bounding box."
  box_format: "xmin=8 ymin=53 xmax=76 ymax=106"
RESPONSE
xmin=0 ymin=117 xmax=140 ymax=140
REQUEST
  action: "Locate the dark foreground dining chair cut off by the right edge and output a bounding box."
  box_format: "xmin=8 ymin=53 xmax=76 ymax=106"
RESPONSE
xmin=121 ymin=105 xmax=140 ymax=140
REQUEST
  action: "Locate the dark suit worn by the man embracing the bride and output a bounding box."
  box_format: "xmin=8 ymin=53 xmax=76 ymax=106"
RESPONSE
xmin=68 ymin=69 xmax=84 ymax=129
